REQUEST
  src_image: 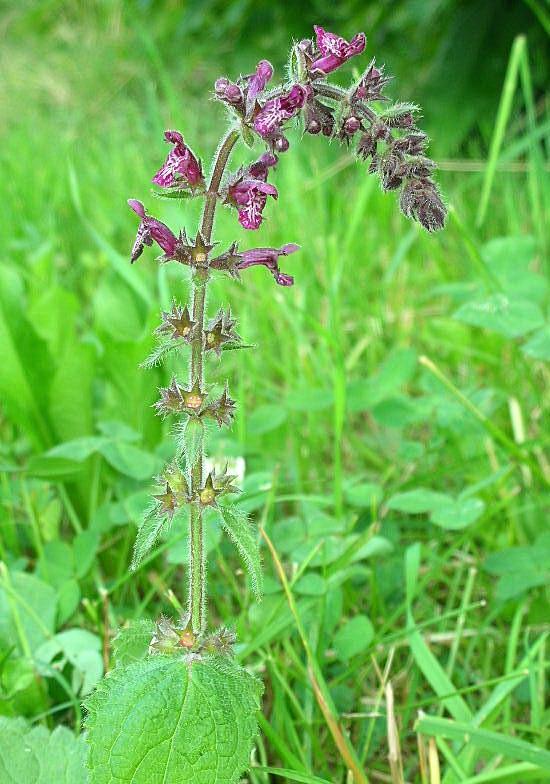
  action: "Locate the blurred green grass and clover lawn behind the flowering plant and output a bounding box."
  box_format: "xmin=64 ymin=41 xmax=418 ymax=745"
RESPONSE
xmin=0 ymin=1 xmax=550 ymax=784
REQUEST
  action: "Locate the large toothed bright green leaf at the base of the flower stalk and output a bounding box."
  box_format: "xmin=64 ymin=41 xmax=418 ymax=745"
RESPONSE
xmin=87 ymin=656 xmax=261 ymax=784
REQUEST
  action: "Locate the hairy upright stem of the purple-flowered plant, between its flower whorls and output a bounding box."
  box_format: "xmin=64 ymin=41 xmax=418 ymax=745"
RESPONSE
xmin=188 ymin=128 xmax=239 ymax=634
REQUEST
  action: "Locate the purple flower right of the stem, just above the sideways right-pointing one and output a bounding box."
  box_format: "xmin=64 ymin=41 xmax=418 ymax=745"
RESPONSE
xmin=227 ymin=153 xmax=279 ymax=229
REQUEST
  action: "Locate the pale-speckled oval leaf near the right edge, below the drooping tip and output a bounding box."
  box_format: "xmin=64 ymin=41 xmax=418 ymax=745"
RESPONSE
xmin=454 ymin=294 xmax=544 ymax=338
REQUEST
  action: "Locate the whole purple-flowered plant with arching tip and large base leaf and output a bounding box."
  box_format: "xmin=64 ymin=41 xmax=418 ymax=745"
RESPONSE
xmin=87 ymin=27 xmax=446 ymax=784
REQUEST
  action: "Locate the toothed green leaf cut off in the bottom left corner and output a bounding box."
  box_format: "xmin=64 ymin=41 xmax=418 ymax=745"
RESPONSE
xmin=0 ymin=716 xmax=89 ymax=784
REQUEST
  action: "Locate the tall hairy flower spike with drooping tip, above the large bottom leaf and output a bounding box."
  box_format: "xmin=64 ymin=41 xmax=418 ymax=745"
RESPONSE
xmin=125 ymin=27 xmax=446 ymax=644
